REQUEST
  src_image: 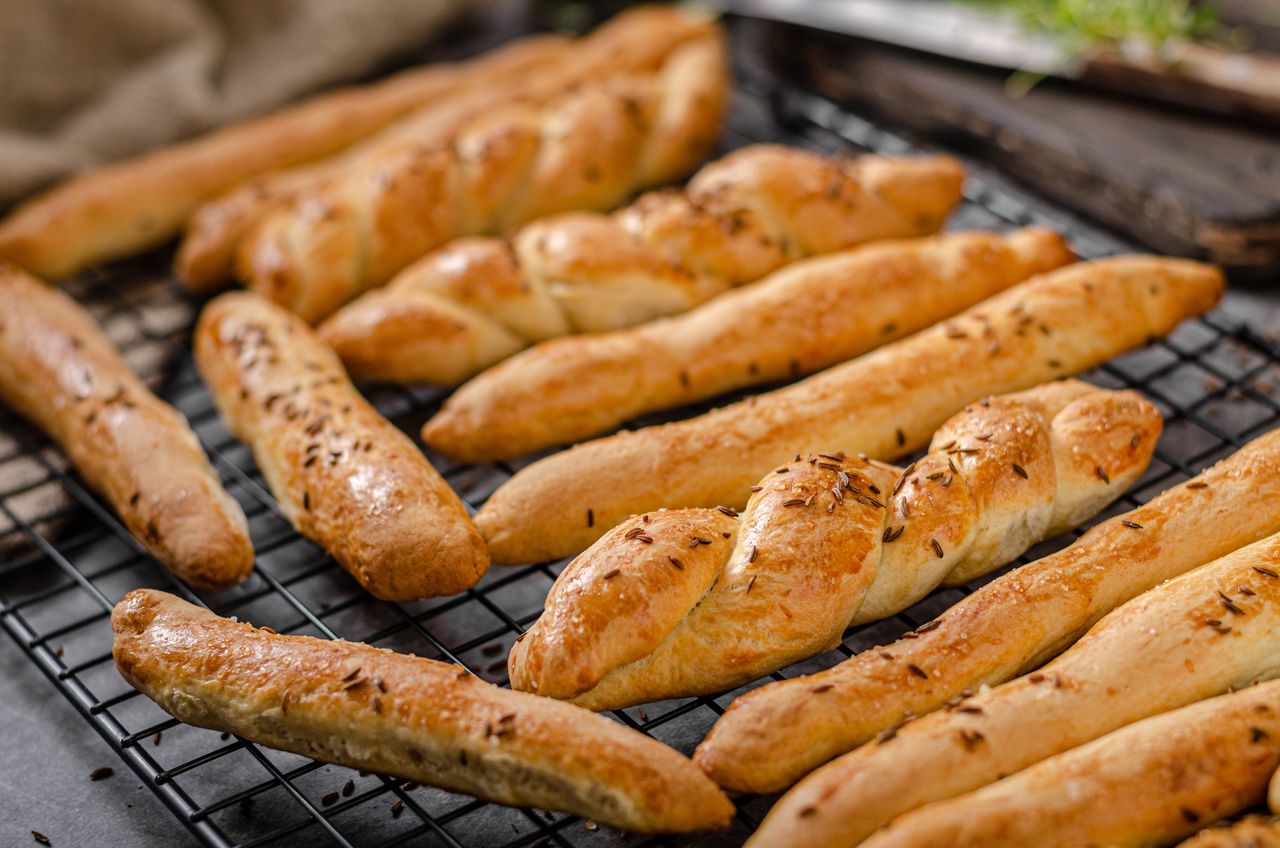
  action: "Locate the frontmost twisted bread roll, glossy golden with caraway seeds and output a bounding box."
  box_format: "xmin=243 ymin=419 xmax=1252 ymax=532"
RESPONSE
xmin=509 ymin=380 xmax=1161 ymax=710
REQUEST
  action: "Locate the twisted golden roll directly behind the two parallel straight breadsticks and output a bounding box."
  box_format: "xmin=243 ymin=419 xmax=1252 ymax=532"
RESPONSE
xmin=320 ymin=145 xmax=967 ymax=383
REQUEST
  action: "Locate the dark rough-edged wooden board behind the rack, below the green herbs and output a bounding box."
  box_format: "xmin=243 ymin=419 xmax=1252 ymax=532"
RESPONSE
xmin=740 ymin=22 xmax=1280 ymax=279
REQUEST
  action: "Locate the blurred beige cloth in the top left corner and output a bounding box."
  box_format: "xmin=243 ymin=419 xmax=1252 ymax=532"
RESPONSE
xmin=0 ymin=0 xmax=472 ymax=208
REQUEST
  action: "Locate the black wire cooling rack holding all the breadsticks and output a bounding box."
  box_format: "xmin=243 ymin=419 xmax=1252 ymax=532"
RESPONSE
xmin=0 ymin=19 xmax=1280 ymax=848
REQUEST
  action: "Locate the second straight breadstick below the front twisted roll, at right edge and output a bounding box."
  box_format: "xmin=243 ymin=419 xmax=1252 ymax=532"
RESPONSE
xmin=758 ymin=535 xmax=1280 ymax=847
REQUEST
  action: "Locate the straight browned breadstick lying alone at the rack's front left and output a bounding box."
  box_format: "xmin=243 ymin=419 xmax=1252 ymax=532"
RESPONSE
xmin=111 ymin=589 xmax=733 ymax=833
